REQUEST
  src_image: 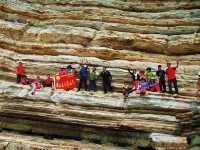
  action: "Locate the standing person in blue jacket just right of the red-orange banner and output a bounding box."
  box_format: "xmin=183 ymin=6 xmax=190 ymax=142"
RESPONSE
xmin=78 ymin=65 xmax=88 ymax=91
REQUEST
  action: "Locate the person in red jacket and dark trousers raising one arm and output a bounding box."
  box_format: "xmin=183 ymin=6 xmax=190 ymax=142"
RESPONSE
xmin=166 ymin=61 xmax=179 ymax=94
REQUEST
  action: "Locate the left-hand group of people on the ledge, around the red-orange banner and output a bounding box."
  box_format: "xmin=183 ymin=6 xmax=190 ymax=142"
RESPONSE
xmin=16 ymin=62 xmax=112 ymax=95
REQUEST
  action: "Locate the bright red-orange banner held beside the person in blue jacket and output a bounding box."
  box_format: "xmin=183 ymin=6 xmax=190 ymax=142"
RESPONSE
xmin=55 ymin=75 xmax=77 ymax=90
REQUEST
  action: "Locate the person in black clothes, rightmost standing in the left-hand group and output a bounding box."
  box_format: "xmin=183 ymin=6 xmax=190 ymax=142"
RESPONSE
xmin=99 ymin=67 xmax=112 ymax=93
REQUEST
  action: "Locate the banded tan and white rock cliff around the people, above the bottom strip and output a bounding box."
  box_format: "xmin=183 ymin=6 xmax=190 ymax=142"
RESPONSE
xmin=0 ymin=0 xmax=200 ymax=150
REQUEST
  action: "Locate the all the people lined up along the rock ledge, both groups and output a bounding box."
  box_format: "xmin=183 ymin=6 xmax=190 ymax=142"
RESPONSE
xmin=16 ymin=61 xmax=200 ymax=99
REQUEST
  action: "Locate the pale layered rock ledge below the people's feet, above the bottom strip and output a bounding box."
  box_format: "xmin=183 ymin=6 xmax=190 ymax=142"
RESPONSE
xmin=0 ymin=81 xmax=200 ymax=150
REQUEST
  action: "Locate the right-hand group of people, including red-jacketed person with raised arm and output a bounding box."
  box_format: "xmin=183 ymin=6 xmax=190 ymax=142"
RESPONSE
xmin=123 ymin=61 xmax=179 ymax=98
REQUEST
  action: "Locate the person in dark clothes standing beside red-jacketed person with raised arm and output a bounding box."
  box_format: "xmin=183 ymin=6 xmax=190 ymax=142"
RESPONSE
xmin=156 ymin=65 xmax=166 ymax=93
